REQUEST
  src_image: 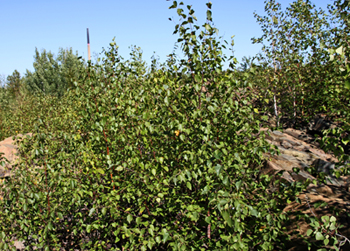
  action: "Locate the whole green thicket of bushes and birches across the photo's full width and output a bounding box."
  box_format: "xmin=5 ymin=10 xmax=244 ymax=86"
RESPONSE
xmin=0 ymin=0 xmax=350 ymax=250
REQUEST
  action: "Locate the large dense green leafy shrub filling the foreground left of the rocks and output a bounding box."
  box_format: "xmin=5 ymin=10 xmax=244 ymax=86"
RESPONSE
xmin=0 ymin=1 xmax=348 ymax=250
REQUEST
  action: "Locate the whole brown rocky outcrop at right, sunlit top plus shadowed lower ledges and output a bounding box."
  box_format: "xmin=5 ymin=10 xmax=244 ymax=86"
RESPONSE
xmin=262 ymin=128 xmax=350 ymax=250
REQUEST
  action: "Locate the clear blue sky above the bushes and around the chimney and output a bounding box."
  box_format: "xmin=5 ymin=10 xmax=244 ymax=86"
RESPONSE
xmin=0 ymin=0 xmax=332 ymax=76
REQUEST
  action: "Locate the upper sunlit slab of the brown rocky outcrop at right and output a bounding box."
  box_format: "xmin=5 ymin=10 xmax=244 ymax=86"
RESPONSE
xmin=262 ymin=128 xmax=350 ymax=188
